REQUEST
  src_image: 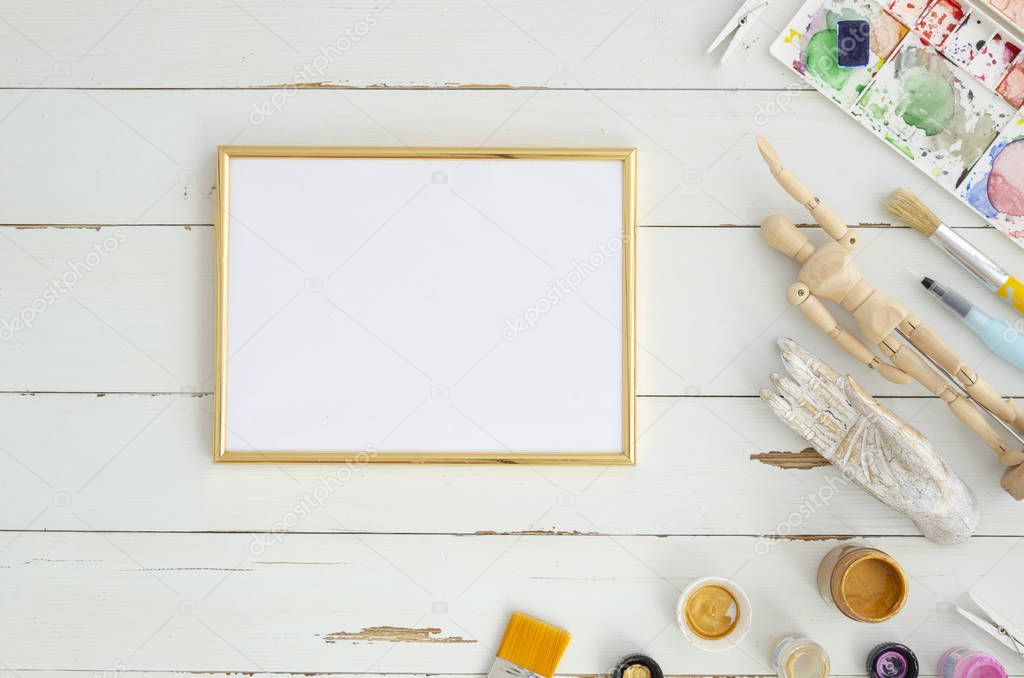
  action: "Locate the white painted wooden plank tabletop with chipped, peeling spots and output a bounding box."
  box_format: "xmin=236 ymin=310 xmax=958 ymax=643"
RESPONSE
xmin=0 ymin=0 xmax=1024 ymax=678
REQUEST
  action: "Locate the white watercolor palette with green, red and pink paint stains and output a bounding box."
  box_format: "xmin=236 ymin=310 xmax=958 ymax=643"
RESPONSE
xmin=771 ymin=0 xmax=1024 ymax=247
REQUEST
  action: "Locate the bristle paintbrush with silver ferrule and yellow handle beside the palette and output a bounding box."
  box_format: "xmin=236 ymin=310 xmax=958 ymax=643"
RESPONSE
xmin=885 ymin=188 xmax=1024 ymax=314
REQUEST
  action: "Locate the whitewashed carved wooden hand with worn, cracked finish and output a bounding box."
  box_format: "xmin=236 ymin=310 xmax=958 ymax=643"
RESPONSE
xmin=761 ymin=339 xmax=978 ymax=544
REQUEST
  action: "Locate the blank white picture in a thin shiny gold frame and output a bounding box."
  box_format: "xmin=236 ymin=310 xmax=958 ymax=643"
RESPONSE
xmin=213 ymin=145 xmax=637 ymax=465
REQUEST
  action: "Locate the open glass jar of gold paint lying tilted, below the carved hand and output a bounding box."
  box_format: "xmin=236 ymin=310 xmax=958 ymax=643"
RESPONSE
xmin=818 ymin=544 xmax=910 ymax=624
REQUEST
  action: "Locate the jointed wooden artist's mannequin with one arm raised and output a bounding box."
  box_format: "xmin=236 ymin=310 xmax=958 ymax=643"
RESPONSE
xmin=758 ymin=137 xmax=1024 ymax=500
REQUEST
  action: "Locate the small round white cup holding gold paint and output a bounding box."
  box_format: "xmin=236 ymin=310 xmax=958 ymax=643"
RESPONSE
xmin=676 ymin=577 xmax=751 ymax=652
